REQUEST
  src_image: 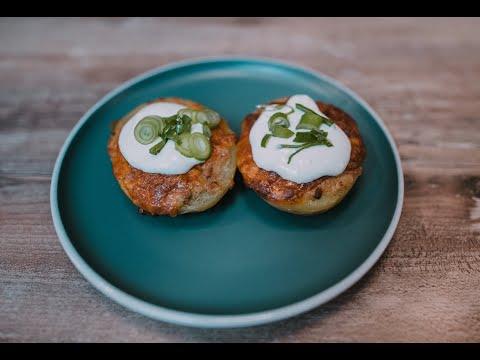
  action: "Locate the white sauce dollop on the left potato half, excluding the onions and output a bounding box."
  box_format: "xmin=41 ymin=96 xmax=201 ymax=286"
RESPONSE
xmin=118 ymin=103 xmax=203 ymax=175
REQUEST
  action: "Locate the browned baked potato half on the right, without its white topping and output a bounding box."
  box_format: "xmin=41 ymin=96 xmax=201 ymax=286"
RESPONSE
xmin=237 ymin=98 xmax=366 ymax=215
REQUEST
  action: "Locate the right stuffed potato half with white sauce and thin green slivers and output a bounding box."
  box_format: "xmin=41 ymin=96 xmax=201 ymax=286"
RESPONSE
xmin=237 ymin=95 xmax=366 ymax=215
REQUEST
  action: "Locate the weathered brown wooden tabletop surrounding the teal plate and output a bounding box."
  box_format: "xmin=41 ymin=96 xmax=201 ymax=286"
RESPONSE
xmin=0 ymin=18 xmax=480 ymax=342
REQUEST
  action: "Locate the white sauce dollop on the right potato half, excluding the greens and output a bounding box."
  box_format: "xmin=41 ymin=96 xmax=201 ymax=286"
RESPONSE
xmin=249 ymin=95 xmax=351 ymax=183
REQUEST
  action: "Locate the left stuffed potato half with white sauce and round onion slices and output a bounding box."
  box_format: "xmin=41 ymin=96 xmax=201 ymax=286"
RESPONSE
xmin=108 ymin=97 xmax=236 ymax=216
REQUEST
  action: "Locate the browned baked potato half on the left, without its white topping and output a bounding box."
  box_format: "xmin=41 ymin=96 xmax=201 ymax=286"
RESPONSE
xmin=108 ymin=98 xmax=236 ymax=216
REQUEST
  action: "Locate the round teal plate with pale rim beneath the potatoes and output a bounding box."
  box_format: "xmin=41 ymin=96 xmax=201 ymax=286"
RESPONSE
xmin=51 ymin=58 xmax=403 ymax=327
